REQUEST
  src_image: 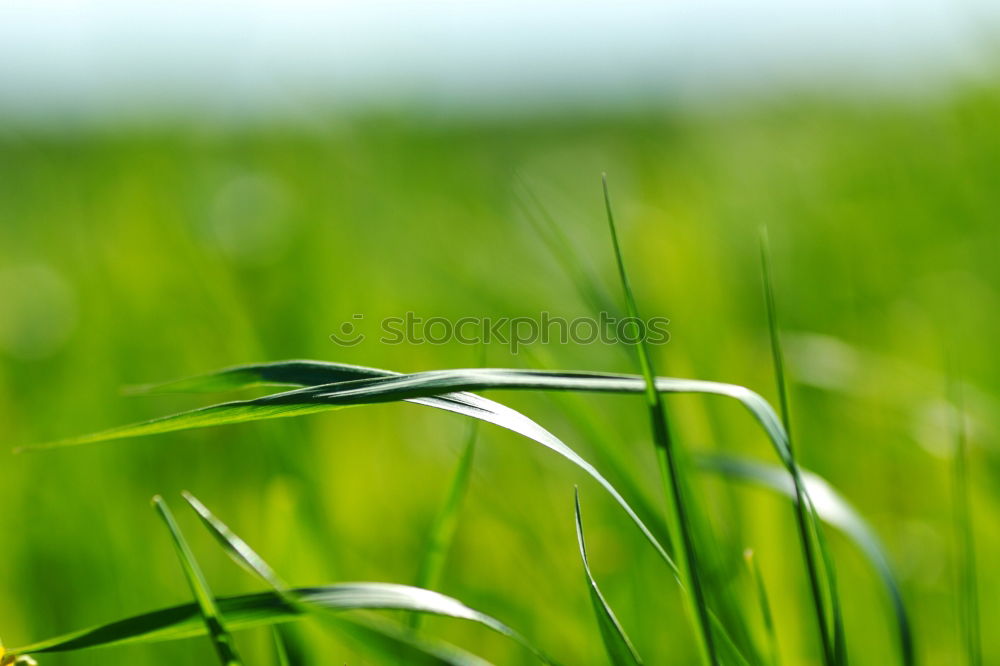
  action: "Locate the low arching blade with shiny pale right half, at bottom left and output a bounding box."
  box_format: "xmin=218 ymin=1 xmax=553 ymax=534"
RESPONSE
xmin=15 ymin=583 xmax=531 ymax=653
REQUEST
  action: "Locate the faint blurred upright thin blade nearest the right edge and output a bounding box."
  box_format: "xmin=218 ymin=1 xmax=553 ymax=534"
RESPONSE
xmin=949 ymin=380 xmax=983 ymax=666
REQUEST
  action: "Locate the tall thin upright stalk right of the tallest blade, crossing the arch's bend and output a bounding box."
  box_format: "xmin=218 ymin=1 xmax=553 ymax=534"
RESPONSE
xmin=760 ymin=228 xmax=838 ymax=666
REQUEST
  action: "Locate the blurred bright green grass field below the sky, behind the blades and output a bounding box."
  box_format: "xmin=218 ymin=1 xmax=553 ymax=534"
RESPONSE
xmin=0 ymin=88 xmax=1000 ymax=665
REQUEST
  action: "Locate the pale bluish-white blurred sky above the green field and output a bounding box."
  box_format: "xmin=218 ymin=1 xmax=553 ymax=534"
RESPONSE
xmin=0 ymin=0 xmax=1000 ymax=122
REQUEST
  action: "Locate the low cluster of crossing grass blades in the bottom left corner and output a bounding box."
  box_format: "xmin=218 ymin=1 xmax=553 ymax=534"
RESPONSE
xmin=9 ymin=493 xmax=553 ymax=666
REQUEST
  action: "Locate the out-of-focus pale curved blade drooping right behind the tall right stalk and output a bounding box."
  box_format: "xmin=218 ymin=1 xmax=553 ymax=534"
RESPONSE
xmin=697 ymin=454 xmax=915 ymax=666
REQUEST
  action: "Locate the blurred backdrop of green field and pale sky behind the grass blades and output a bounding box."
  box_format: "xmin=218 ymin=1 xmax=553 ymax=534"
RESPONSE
xmin=0 ymin=0 xmax=1000 ymax=666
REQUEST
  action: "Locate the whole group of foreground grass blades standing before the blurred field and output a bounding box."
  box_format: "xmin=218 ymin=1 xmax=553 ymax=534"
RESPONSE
xmin=12 ymin=182 xmax=914 ymax=666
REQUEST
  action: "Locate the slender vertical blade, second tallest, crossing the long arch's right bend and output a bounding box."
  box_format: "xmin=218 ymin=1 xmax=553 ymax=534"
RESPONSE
xmin=760 ymin=228 xmax=845 ymax=666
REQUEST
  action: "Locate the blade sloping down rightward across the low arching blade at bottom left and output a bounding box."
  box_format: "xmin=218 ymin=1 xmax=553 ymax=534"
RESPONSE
xmin=183 ymin=491 xmax=500 ymax=666
